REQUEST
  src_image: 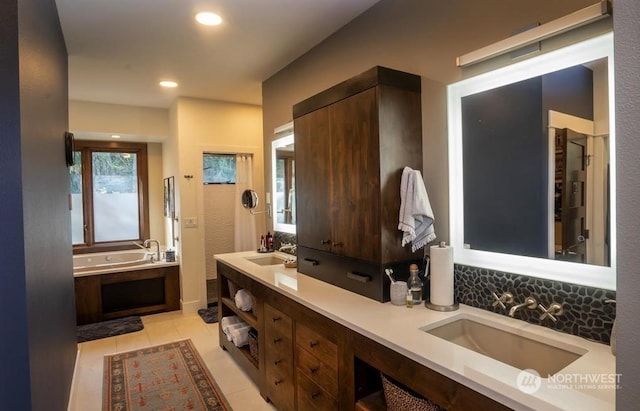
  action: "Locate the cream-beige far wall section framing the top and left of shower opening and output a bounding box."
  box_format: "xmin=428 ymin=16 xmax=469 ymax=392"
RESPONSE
xmin=169 ymin=97 xmax=265 ymax=312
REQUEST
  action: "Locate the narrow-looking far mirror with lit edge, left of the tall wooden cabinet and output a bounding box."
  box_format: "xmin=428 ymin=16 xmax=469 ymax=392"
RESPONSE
xmin=271 ymin=123 xmax=296 ymax=234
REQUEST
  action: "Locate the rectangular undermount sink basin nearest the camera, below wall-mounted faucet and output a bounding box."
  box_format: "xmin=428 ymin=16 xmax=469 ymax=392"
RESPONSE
xmin=420 ymin=316 xmax=586 ymax=378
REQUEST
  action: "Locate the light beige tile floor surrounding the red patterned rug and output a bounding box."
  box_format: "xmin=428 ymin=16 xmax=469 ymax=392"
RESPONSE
xmin=69 ymin=311 xmax=275 ymax=411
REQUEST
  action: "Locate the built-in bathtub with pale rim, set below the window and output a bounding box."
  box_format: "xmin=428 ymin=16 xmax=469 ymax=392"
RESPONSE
xmin=73 ymin=250 xmax=178 ymax=277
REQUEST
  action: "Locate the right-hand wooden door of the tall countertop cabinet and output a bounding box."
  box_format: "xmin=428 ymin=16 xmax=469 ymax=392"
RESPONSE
xmin=330 ymin=88 xmax=384 ymax=261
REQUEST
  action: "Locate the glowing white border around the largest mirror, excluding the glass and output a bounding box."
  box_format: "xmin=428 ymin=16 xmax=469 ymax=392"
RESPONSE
xmin=447 ymin=33 xmax=616 ymax=290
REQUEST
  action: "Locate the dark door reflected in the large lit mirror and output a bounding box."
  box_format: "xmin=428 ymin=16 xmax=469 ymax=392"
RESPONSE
xmin=556 ymin=128 xmax=588 ymax=263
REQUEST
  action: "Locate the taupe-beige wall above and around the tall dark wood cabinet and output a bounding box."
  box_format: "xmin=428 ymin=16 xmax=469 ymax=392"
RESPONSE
xmin=262 ymin=0 xmax=594 ymax=245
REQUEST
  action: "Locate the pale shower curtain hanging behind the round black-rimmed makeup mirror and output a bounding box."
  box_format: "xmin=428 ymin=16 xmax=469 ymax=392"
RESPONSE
xmin=235 ymin=154 xmax=258 ymax=252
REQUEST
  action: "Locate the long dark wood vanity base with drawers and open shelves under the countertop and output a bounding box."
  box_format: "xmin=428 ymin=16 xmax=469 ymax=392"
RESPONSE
xmin=217 ymin=261 xmax=507 ymax=411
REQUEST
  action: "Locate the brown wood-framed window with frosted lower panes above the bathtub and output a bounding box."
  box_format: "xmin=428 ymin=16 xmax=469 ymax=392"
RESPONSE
xmin=70 ymin=141 xmax=149 ymax=252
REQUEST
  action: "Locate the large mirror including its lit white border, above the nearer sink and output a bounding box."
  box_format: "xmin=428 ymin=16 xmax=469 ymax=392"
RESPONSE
xmin=447 ymin=33 xmax=616 ymax=289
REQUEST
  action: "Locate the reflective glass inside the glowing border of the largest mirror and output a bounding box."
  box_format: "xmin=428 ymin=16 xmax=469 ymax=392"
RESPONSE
xmin=461 ymin=59 xmax=609 ymax=265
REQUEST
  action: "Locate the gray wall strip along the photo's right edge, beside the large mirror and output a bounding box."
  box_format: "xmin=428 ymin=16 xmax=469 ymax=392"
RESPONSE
xmin=614 ymin=0 xmax=640 ymax=410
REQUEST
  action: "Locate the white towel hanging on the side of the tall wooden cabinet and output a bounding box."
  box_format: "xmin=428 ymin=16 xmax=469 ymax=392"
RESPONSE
xmin=398 ymin=167 xmax=436 ymax=252
